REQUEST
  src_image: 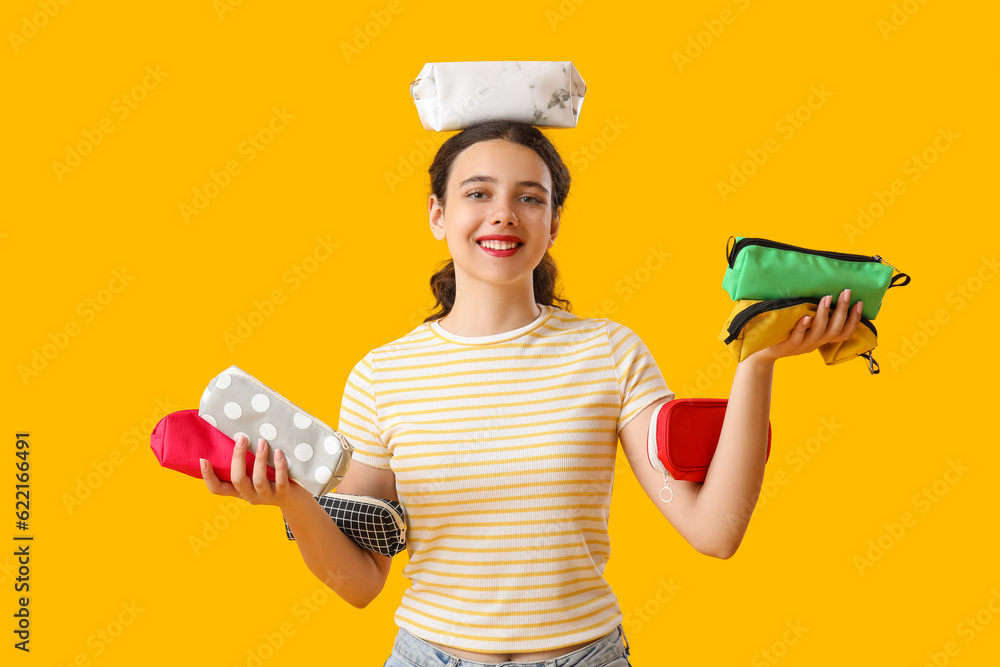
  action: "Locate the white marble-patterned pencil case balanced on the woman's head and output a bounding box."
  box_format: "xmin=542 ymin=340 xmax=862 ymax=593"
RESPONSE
xmin=410 ymin=60 xmax=587 ymax=132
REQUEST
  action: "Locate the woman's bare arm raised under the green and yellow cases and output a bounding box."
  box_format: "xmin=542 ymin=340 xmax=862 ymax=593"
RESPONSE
xmin=619 ymin=290 xmax=862 ymax=558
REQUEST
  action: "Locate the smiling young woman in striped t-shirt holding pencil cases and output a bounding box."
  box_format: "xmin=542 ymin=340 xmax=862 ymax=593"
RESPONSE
xmin=203 ymin=121 xmax=861 ymax=667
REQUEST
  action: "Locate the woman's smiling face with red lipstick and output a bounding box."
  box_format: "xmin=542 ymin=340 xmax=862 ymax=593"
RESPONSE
xmin=428 ymin=139 xmax=559 ymax=293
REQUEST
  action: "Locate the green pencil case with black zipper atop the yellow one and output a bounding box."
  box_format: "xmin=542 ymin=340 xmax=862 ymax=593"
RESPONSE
xmin=722 ymin=236 xmax=910 ymax=320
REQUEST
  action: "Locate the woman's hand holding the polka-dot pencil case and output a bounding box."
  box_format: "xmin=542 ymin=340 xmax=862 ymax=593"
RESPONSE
xmin=201 ymin=434 xmax=313 ymax=511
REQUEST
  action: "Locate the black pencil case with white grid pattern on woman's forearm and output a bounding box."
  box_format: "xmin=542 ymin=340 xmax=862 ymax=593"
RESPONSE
xmin=285 ymin=493 xmax=406 ymax=557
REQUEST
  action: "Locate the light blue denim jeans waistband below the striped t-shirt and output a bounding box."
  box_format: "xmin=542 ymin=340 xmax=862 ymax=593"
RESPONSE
xmin=393 ymin=625 xmax=629 ymax=667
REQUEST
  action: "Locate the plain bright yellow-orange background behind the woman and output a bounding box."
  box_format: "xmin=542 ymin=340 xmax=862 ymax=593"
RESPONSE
xmin=0 ymin=0 xmax=1000 ymax=667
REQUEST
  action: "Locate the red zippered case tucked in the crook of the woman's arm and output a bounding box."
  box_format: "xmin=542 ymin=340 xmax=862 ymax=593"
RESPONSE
xmin=647 ymin=398 xmax=771 ymax=502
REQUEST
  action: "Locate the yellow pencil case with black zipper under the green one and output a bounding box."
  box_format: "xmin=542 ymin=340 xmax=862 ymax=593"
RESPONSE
xmin=719 ymin=297 xmax=879 ymax=375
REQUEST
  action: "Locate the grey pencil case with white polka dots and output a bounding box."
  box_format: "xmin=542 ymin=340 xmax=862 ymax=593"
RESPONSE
xmin=198 ymin=366 xmax=354 ymax=496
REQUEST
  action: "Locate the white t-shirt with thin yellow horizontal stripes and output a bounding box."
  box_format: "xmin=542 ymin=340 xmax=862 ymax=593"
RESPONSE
xmin=338 ymin=304 xmax=674 ymax=653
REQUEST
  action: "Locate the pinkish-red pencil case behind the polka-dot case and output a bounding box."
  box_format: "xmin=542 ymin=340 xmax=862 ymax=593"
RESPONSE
xmin=149 ymin=410 xmax=274 ymax=482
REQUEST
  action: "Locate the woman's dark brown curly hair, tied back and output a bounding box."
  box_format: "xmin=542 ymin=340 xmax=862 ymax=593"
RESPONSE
xmin=424 ymin=120 xmax=573 ymax=322
